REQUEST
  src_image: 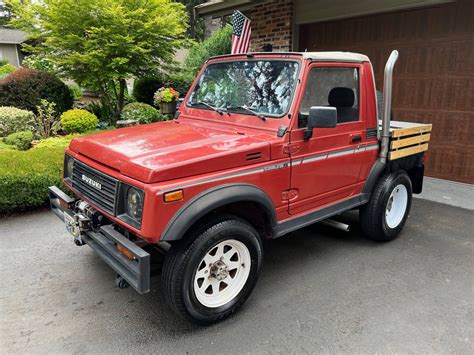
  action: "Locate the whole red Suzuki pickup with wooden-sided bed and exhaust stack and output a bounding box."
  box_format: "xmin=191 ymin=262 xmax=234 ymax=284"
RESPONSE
xmin=49 ymin=51 xmax=431 ymax=324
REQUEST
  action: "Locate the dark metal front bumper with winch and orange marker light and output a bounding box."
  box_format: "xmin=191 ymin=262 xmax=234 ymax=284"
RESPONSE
xmin=48 ymin=186 xmax=150 ymax=294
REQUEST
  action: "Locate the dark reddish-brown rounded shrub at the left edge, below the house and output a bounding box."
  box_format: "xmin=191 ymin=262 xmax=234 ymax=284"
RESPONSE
xmin=0 ymin=68 xmax=73 ymax=114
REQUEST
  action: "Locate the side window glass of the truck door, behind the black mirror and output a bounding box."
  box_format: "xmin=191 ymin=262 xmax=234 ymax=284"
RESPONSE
xmin=298 ymin=67 xmax=359 ymax=128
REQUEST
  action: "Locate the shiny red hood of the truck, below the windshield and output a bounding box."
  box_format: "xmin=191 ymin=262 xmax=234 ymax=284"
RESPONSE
xmin=69 ymin=121 xmax=270 ymax=183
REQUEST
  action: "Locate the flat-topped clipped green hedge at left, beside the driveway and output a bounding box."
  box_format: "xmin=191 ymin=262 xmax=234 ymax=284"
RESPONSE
xmin=0 ymin=147 xmax=64 ymax=214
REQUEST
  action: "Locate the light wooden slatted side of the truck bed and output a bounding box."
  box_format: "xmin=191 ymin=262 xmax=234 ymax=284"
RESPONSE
xmin=379 ymin=121 xmax=432 ymax=160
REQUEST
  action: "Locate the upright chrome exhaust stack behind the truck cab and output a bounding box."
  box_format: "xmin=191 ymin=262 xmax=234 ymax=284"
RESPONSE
xmin=379 ymin=50 xmax=398 ymax=164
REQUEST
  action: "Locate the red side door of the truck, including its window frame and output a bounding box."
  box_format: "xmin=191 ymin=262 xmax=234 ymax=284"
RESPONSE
xmin=289 ymin=63 xmax=366 ymax=214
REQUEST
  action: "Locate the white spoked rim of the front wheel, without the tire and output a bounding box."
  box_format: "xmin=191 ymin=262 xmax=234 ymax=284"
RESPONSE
xmin=194 ymin=239 xmax=251 ymax=308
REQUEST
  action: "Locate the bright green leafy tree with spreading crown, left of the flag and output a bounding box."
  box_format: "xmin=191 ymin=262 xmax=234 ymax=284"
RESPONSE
xmin=8 ymin=0 xmax=188 ymax=119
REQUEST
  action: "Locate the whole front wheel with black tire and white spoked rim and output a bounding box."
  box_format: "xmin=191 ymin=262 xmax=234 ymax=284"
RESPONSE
xmin=162 ymin=215 xmax=263 ymax=325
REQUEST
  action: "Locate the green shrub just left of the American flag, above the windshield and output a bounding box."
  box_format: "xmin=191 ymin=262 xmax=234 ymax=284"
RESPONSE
xmin=184 ymin=25 xmax=232 ymax=77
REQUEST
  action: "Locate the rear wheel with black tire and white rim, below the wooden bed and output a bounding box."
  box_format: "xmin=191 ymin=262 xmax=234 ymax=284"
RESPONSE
xmin=359 ymin=170 xmax=412 ymax=242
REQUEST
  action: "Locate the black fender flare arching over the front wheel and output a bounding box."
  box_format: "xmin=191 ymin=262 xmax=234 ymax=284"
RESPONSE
xmin=160 ymin=183 xmax=277 ymax=242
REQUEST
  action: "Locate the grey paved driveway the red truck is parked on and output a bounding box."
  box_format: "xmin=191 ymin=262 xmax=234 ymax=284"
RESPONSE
xmin=0 ymin=200 xmax=474 ymax=354
